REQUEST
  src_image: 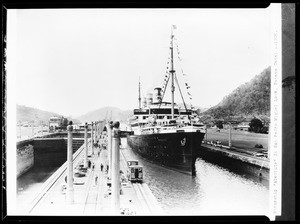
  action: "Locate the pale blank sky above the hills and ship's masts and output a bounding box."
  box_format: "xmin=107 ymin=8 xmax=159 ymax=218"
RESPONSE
xmin=7 ymin=8 xmax=271 ymax=117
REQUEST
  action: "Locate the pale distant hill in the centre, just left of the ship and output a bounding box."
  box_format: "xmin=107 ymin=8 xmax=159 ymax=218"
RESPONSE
xmin=76 ymin=107 xmax=133 ymax=123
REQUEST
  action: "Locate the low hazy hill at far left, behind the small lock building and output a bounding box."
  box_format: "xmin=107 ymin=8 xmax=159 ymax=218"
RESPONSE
xmin=17 ymin=105 xmax=79 ymax=125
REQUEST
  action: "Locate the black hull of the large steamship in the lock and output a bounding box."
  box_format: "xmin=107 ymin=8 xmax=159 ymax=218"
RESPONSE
xmin=127 ymin=132 xmax=205 ymax=174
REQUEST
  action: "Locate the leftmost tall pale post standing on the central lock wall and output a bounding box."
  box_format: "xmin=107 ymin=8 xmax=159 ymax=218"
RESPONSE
xmin=67 ymin=121 xmax=74 ymax=204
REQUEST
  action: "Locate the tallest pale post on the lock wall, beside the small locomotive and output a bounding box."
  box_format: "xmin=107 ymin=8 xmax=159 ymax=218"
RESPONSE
xmin=111 ymin=122 xmax=120 ymax=215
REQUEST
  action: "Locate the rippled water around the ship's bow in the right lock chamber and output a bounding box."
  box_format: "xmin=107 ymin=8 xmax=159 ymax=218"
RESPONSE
xmin=122 ymin=140 xmax=269 ymax=215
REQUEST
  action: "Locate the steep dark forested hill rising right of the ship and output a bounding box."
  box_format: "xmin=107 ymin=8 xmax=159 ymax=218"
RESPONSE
xmin=203 ymin=67 xmax=271 ymax=119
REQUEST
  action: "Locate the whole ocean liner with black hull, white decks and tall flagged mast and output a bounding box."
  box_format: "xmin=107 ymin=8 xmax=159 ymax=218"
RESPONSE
xmin=127 ymin=26 xmax=205 ymax=175
